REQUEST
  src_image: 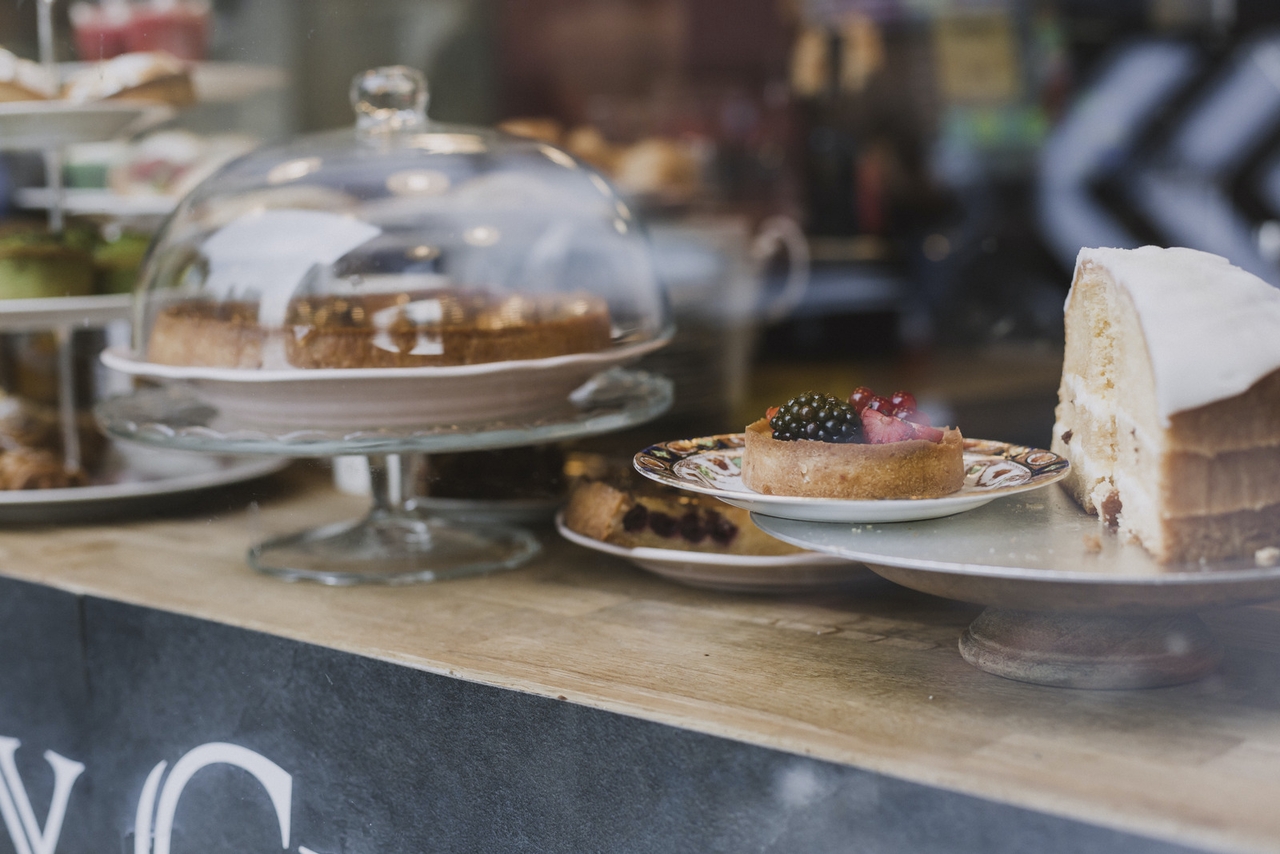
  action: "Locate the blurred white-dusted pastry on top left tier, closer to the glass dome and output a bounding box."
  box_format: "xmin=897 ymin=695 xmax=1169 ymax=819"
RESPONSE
xmin=63 ymin=51 xmax=196 ymax=106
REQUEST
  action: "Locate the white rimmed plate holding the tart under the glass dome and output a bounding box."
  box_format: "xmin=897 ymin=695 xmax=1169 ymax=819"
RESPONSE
xmin=102 ymin=338 xmax=667 ymax=430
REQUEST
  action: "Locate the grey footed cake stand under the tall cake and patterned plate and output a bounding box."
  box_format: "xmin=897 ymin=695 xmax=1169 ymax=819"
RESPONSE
xmin=751 ymin=487 xmax=1280 ymax=688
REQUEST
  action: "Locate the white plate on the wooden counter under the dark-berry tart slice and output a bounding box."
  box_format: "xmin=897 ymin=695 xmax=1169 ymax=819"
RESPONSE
xmin=556 ymin=513 xmax=868 ymax=593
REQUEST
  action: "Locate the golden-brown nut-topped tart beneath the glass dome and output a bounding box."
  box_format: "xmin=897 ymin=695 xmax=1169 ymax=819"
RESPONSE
xmin=147 ymin=289 xmax=611 ymax=369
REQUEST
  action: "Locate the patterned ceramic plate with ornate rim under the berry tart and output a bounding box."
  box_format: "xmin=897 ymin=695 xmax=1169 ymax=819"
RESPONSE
xmin=635 ymin=433 xmax=1071 ymax=522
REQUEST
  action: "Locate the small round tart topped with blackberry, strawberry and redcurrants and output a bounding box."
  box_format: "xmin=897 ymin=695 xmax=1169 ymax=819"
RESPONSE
xmin=742 ymin=387 xmax=965 ymax=501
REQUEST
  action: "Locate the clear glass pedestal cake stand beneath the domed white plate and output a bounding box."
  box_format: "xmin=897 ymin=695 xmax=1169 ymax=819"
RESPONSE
xmin=97 ymin=369 xmax=672 ymax=585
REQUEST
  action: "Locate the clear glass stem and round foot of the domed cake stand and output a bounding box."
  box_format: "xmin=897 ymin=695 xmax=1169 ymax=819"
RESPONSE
xmin=248 ymin=455 xmax=541 ymax=585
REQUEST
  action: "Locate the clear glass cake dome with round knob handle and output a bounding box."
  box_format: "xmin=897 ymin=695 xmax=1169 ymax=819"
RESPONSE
xmin=134 ymin=67 xmax=671 ymax=371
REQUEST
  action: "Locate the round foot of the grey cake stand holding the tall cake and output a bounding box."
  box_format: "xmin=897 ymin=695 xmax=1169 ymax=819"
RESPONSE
xmin=960 ymin=607 xmax=1222 ymax=689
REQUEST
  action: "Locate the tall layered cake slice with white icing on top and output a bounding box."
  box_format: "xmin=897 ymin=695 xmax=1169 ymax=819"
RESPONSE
xmin=1052 ymin=246 xmax=1280 ymax=563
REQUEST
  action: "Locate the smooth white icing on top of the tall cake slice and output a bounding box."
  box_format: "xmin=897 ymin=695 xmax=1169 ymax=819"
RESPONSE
xmin=1068 ymin=246 xmax=1280 ymax=426
